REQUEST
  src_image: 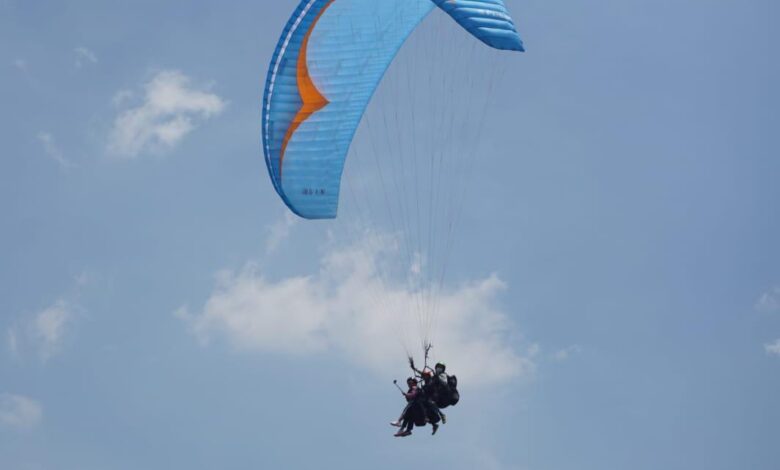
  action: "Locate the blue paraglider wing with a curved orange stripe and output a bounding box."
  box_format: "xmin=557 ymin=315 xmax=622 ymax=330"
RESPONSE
xmin=262 ymin=0 xmax=522 ymax=219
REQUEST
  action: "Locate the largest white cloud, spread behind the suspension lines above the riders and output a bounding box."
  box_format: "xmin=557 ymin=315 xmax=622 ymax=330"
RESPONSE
xmin=176 ymin=237 xmax=538 ymax=386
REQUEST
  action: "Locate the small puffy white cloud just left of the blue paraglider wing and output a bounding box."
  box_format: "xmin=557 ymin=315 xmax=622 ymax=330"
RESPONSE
xmin=109 ymin=70 xmax=226 ymax=158
